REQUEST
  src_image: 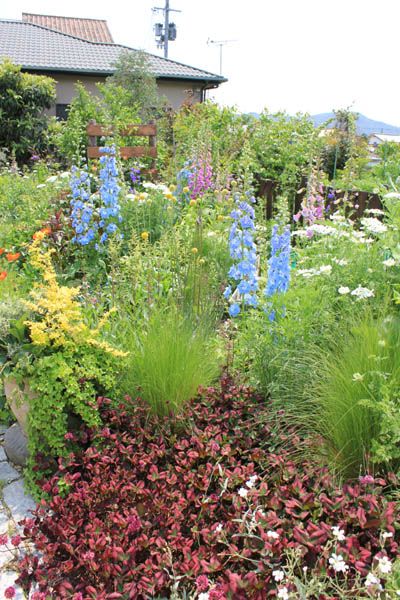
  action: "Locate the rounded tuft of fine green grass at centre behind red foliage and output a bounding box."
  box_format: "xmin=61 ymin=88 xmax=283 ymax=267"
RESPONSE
xmin=122 ymin=307 xmax=218 ymax=416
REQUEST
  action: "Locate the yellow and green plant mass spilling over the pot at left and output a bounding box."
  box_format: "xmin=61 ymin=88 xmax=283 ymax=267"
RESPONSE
xmin=11 ymin=231 xmax=126 ymax=492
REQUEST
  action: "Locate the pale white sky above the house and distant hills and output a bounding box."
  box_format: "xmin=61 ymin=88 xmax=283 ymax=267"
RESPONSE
xmin=0 ymin=0 xmax=400 ymax=126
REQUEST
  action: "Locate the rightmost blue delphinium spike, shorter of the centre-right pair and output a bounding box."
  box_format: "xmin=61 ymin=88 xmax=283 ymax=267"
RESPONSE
xmin=265 ymin=225 xmax=290 ymax=321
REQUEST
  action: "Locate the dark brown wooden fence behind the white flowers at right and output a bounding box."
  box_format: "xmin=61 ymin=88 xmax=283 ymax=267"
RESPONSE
xmin=257 ymin=179 xmax=383 ymax=219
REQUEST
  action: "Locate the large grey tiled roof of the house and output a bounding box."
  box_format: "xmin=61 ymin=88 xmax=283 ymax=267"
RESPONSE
xmin=0 ymin=20 xmax=226 ymax=83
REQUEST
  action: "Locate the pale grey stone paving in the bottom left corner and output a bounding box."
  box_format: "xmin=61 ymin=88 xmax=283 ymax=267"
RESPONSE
xmin=0 ymin=426 xmax=36 ymax=600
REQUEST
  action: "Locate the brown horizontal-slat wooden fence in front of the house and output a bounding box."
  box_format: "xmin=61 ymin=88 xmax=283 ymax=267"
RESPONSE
xmin=86 ymin=121 xmax=157 ymax=175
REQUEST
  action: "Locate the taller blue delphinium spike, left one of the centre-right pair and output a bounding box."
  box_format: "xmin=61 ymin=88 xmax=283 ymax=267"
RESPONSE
xmin=224 ymin=192 xmax=258 ymax=317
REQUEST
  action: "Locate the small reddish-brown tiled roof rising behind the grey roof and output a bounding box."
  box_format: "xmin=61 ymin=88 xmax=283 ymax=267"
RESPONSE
xmin=22 ymin=13 xmax=114 ymax=44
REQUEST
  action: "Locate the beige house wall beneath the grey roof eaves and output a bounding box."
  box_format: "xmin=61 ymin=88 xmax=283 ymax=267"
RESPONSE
xmin=44 ymin=73 xmax=202 ymax=115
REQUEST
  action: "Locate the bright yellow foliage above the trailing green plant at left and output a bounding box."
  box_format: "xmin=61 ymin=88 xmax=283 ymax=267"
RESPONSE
xmin=26 ymin=232 xmax=126 ymax=357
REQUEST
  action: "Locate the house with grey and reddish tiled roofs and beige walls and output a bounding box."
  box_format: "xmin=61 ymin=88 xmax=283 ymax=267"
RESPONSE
xmin=0 ymin=13 xmax=226 ymax=118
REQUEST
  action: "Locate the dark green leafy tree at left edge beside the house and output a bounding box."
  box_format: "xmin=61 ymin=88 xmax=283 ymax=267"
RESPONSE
xmin=0 ymin=60 xmax=56 ymax=162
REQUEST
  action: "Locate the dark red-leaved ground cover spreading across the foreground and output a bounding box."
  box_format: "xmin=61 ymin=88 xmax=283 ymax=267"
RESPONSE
xmin=14 ymin=378 xmax=398 ymax=600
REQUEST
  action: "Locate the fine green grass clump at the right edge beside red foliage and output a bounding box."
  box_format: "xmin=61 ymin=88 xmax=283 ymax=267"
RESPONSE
xmin=310 ymin=317 xmax=400 ymax=477
